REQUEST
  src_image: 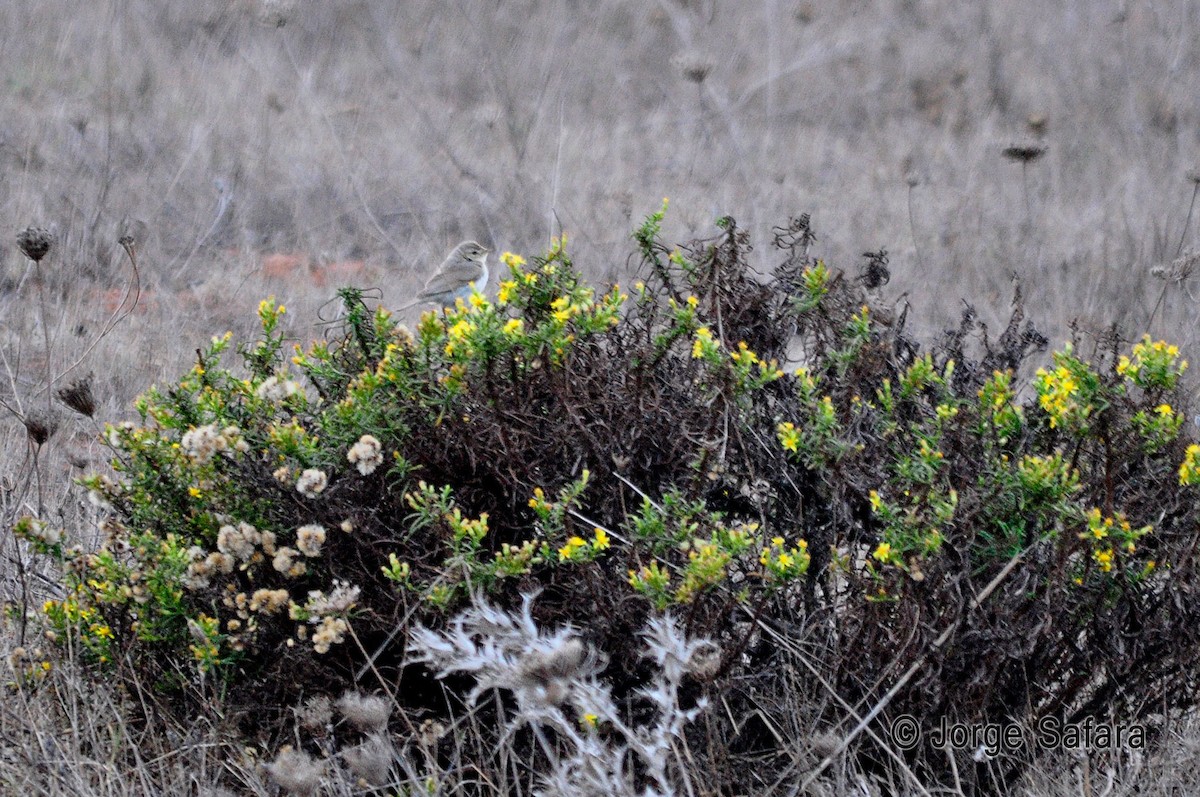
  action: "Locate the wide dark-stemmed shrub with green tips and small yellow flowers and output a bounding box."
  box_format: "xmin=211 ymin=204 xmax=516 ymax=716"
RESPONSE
xmin=17 ymin=204 xmax=1200 ymax=791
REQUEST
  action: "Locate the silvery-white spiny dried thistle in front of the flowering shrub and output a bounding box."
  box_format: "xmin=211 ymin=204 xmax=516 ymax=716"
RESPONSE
xmin=410 ymin=594 xmax=721 ymax=796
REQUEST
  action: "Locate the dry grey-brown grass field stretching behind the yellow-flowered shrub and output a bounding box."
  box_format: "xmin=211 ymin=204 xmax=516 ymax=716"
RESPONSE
xmin=0 ymin=0 xmax=1200 ymax=795
